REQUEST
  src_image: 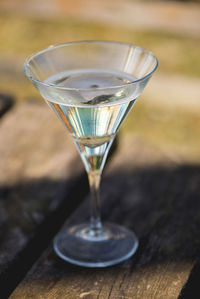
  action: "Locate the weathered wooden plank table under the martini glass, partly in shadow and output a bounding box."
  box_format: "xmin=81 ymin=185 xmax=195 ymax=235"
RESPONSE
xmin=0 ymin=101 xmax=200 ymax=299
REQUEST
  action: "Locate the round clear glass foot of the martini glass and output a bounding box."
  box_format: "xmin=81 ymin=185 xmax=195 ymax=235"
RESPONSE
xmin=54 ymin=223 xmax=138 ymax=267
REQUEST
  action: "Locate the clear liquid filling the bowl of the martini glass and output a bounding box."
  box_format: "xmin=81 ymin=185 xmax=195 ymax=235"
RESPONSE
xmin=44 ymin=69 xmax=138 ymax=172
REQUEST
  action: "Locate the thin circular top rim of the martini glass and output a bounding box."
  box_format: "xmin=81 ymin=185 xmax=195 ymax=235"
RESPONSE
xmin=24 ymin=40 xmax=158 ymax=91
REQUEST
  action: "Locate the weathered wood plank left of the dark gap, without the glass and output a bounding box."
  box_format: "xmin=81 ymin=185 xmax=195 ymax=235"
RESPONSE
xmin=0 ymin=102 xmax=86 ymax=298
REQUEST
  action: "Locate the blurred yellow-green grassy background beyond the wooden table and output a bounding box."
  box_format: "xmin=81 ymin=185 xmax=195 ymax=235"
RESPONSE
xmin=0 ymin=0 xmax=200 ymax=163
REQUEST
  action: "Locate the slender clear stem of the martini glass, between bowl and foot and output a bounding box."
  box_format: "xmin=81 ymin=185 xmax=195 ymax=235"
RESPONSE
xmin=88 ymin=171 xmax=102 ymax=236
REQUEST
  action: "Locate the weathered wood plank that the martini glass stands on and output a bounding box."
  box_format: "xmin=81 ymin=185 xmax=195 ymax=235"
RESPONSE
xmin=10 ymin=136 xmax=200 ymax=299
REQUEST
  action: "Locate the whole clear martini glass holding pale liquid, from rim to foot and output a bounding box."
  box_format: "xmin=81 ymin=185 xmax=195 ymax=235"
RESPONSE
xmin=24 ymin=41 xmax=158 ymax=267
